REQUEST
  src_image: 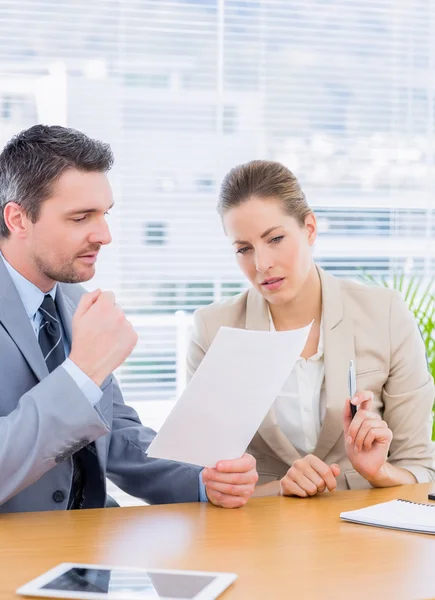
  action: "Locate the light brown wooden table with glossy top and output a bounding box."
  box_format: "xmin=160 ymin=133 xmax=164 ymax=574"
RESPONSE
xmin=0 ymin=484 xmax=435 ymax=600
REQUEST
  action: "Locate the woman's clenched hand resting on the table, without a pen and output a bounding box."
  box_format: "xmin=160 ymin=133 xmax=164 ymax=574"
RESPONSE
xmin=281 ymin=454 xmax=340 ymax=498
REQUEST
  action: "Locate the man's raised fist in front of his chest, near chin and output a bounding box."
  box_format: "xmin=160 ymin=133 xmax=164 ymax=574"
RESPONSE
xmin=69 ymin=290 xmax=138 ymax=386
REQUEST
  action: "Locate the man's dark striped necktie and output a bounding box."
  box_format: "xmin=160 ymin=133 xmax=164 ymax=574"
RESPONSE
xmin=38 ymin=294 xmax=84 ymax=509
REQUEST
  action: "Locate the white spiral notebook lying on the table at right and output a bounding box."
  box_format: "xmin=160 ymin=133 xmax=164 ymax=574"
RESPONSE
xmin=340 ymin=500 xmax=435 ymax=534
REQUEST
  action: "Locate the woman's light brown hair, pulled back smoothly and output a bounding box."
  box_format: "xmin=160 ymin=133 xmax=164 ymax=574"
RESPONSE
xmin=217 ymin=160 xmax=313 ymax=226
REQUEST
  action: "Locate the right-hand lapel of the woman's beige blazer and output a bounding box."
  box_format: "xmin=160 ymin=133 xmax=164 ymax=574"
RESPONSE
xmin=314 ymin=269 xmax=355 ymax=460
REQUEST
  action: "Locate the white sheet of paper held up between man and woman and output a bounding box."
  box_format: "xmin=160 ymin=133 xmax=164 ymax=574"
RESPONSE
xmin=147 ymin=325 xmax=311 ymax=467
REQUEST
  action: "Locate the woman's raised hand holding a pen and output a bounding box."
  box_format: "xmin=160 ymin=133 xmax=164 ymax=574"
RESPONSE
xmin=343 ymin=391 xmax=393 ymax=482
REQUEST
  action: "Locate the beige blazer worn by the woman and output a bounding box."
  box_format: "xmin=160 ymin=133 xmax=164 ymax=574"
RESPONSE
xmin=187 ymin=269 xmax=435 ymax=489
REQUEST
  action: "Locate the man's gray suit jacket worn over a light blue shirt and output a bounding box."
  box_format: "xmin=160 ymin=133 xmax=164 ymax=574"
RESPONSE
xmin=0 ymin=260 xmax=200 ymax=512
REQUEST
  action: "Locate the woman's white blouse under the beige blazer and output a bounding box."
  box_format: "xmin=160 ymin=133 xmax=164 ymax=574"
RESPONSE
xmin=269 ymin=311 xmax=326 ymax=456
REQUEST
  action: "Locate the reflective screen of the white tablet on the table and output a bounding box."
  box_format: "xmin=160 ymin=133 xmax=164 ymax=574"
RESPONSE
xmin=41 ymin=567 xmax=215 ymax=600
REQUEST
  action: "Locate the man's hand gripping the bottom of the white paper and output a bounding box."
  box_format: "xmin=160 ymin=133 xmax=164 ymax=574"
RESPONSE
xmin=202 ymin=454 xmax=258 ymax=508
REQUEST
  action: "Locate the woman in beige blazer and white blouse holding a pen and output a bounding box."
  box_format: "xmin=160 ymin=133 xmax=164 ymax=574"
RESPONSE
xmin=188 ymin=161 xmax=435 ymax=497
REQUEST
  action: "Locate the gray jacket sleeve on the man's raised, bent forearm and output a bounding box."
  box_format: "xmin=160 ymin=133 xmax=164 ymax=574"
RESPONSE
xmin=0 ymin=366 xmax=109 ymax=504
